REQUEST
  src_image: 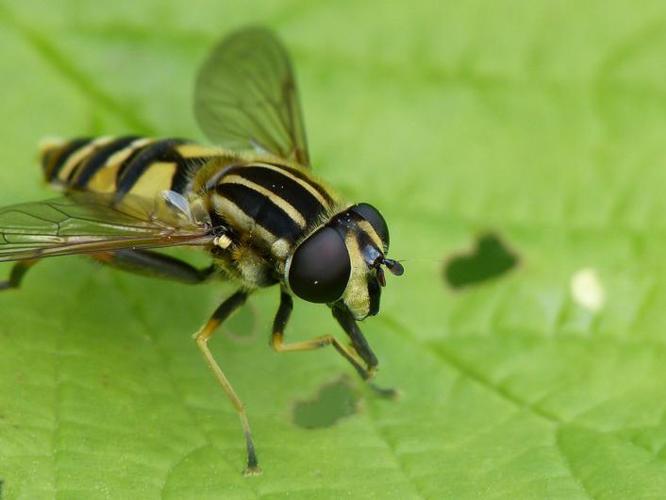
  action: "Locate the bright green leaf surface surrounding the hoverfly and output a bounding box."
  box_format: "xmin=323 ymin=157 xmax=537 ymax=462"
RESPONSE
xmin=0 ymin=0 xmax=666 ymax=500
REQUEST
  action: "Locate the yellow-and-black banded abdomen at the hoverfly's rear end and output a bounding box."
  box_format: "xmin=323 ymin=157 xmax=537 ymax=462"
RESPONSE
xmin=41 ymin=136 xmax=219 ymax=199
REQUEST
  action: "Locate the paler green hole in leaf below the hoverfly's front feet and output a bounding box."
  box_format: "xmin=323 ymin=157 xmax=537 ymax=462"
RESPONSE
xmin=294 ymin=377 xmax=358 ymax=429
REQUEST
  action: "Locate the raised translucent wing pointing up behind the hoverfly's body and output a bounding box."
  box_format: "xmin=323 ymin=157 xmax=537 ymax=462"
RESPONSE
xmin=189 ymin=27 xmax=310 ymax=166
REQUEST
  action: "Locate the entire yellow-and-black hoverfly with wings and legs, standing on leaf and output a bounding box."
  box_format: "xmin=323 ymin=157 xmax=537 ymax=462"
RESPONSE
xmin=0 ymin=28 xmax=403 ymax=474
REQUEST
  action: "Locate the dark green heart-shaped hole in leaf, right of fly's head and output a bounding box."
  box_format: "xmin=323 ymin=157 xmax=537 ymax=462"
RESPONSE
xmin=444 ymin=233 xmax=518 ymax=288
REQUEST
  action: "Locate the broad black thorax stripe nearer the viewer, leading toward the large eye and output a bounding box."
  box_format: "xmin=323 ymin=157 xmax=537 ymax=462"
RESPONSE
xmin=216 ymin=183 xmax=302 ymax=241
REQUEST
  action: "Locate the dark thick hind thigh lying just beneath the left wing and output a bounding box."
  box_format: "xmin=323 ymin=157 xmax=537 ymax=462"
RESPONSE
xmin=93 ymin=250 xmax=215 ymax=284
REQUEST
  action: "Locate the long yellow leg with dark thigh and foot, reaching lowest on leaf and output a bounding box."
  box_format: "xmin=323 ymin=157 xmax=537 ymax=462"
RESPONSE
xmin=194 ymin=290 xmax=261 ymax=475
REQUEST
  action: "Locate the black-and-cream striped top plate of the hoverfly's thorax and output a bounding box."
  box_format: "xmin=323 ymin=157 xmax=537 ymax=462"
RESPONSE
xmin=212 ymin=163 xmax=335 ymax=258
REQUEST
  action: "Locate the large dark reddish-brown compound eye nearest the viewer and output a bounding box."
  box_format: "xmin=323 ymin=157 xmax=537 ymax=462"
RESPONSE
xmin=289 ymin=227 xmax=351 ymax=303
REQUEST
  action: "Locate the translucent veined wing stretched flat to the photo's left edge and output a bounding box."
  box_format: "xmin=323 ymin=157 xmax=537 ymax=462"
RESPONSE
xmin=0 ymin=193 xmax=214 ymax=261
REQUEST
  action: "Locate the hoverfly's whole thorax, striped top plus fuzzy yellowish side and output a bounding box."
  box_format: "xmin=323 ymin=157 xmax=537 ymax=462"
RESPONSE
xmin=193 ymin=157 xmax=338 ymax=286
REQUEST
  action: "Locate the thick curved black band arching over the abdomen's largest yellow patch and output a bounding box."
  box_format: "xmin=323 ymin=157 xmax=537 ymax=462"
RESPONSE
xmin=115 ymin=139 xmax=186 ymax=202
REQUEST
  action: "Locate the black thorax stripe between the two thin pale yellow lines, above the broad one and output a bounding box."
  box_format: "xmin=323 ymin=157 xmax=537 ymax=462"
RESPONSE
xmin=225 ymin=166 xmax=324 ymax=226
